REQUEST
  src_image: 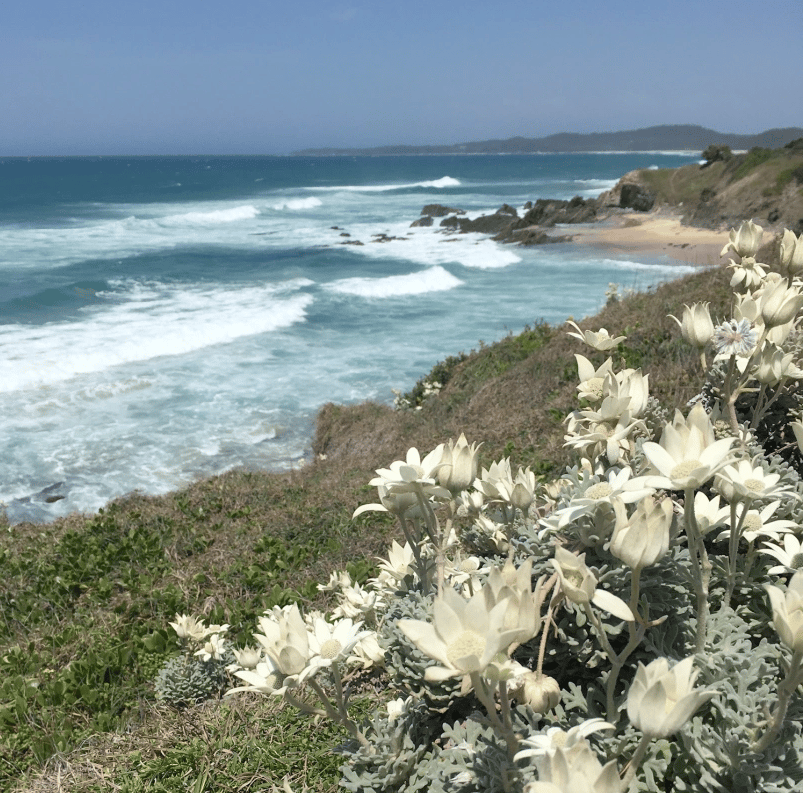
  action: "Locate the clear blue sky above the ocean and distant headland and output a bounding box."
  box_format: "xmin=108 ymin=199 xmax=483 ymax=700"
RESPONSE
xmin=0 ymin=0 xmax=803 ymax=156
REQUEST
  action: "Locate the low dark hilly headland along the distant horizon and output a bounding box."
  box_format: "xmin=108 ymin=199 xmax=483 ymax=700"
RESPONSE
xmin=293 ymin=124 xmax=803 ymax=157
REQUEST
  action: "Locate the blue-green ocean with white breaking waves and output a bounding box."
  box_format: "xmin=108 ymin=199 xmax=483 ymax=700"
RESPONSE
xmin=0 ymin=152 xmax=699 ymax=522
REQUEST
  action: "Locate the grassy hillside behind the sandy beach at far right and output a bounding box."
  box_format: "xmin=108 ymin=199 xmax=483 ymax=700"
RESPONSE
xmin=635 ymin=147 xmax=803 ymax=234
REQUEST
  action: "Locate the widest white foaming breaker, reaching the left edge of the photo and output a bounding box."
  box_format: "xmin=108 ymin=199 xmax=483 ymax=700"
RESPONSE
xmin=0 ymin=279 xmax=313 ymax=392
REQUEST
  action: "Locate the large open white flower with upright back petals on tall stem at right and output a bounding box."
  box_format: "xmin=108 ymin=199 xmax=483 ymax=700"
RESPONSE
xmin=642 ymin=402 xmax=735 ymax=490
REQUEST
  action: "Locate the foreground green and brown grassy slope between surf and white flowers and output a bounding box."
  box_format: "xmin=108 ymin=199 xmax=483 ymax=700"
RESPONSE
xmin=0 ymin=258 xmax=744 ymax=793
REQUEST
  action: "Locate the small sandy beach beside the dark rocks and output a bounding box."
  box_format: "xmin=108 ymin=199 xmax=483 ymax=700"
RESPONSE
xmin=567 ymin=210 xmax=728 ymax=267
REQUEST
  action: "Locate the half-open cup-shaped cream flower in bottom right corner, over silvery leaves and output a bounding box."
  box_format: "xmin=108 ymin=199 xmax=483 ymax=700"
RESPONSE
xmin=627 ymin=656 xmax=716 ymax=738
